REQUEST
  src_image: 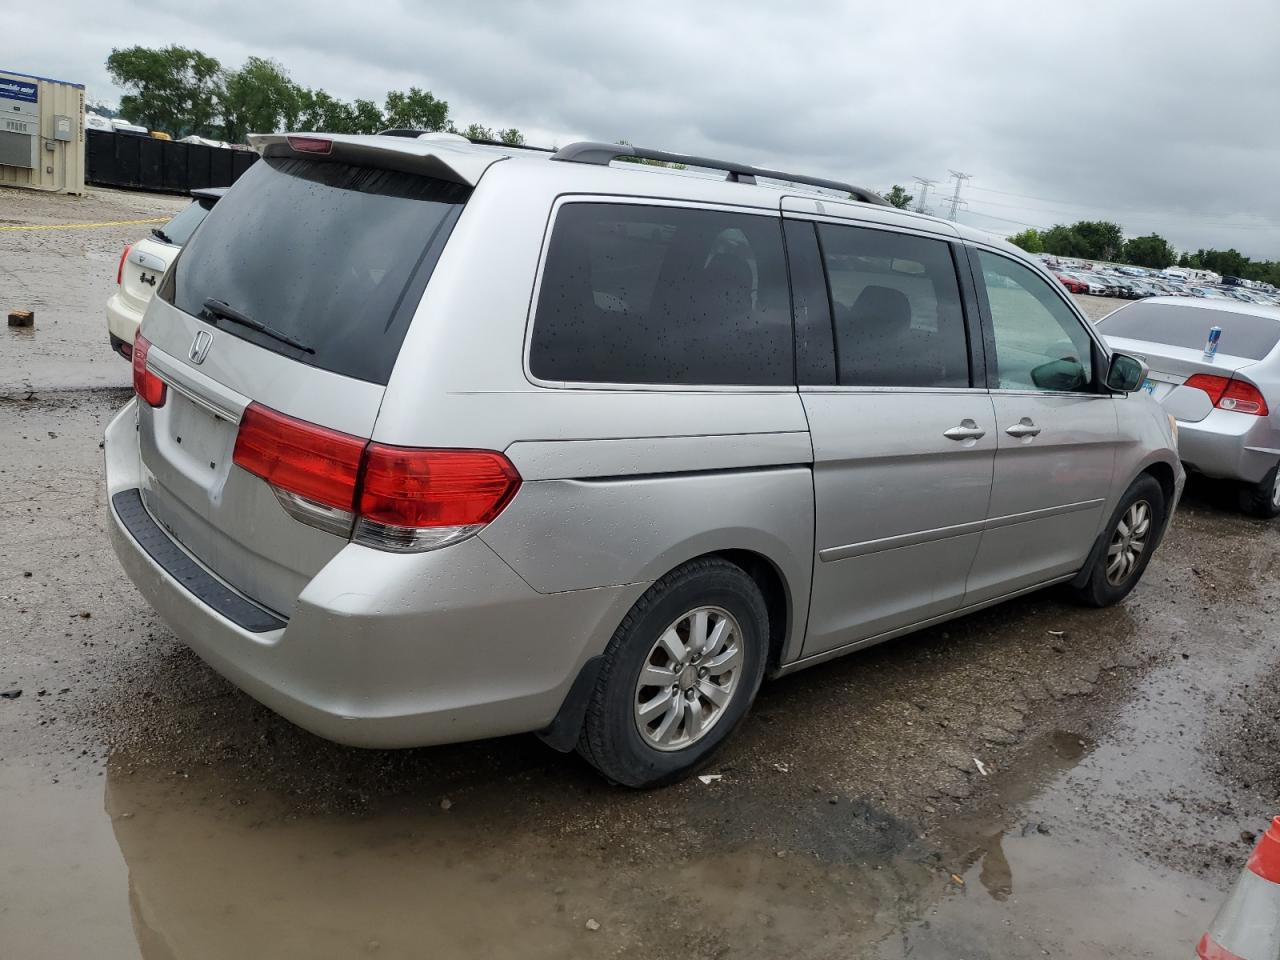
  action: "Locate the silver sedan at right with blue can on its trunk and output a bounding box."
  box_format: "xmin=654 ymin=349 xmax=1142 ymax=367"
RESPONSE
xmin=1097 ymin=297 xmax=1280 ymax=518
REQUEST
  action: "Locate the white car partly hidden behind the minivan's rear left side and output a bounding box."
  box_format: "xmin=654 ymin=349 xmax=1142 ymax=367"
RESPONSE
xmin=106 ymin=187 xmax=227 ymax=360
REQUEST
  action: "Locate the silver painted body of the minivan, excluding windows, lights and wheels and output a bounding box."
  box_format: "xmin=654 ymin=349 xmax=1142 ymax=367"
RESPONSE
xmin=106 ymin=134 xmax=1181 ymax=746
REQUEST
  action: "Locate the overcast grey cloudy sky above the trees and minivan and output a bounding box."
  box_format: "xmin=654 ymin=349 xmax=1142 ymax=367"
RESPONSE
xmin=10 ymin=0 xmax=1280 ymax=259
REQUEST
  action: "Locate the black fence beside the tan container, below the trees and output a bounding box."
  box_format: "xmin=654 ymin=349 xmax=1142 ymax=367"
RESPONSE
xmin=84 ymin=131 xmax=257 ymax=193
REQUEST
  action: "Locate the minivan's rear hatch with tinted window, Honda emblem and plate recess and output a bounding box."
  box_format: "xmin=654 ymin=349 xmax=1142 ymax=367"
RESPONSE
xmin=132 ymin=137 xmax=481 ymax=617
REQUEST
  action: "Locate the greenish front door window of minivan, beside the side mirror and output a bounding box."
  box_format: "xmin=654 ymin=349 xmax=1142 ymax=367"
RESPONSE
xmin=978 ymin=250 xmax=1093 ymax=393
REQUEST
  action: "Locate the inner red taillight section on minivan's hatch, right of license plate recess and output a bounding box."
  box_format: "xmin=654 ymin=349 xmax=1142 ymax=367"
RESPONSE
xmin=232 ymin=403 xmax=365 ymax=511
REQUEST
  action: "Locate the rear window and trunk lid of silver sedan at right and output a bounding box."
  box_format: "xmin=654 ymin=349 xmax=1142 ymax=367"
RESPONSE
xmin=1097 ymin=301 xmax=1280 ymax=422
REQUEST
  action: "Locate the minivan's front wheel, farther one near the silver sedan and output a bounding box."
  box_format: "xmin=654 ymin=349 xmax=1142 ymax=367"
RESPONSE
xmin=1070 ymin=475 xmax=1166 ymax=607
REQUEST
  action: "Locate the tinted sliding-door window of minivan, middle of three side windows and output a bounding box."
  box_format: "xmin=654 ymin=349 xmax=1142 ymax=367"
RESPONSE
xmin=818 ymin=224 xmax=969 ymax=387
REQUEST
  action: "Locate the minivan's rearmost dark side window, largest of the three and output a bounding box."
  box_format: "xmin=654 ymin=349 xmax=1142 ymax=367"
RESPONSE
xmin=530 ymin=204 xmax=792 ymax=385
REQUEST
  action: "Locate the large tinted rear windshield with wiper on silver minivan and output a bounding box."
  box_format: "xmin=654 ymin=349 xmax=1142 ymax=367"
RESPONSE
xmin=173 ymin=157 xmax=471 ymax=384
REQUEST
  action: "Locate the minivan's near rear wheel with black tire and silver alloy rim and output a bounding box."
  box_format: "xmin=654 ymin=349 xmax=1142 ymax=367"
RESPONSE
xmin=577 ymin=557 xmax=769 ymax=787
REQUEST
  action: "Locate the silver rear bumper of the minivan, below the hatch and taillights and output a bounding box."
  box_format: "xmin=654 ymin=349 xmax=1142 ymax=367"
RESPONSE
xmin=105 ymin=402 xmax=645 ymax=748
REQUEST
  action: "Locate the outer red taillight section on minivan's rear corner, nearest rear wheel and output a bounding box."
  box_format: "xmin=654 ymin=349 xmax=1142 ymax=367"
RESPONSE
xmin=360 ymin=443 xmax=520 ymax=529
